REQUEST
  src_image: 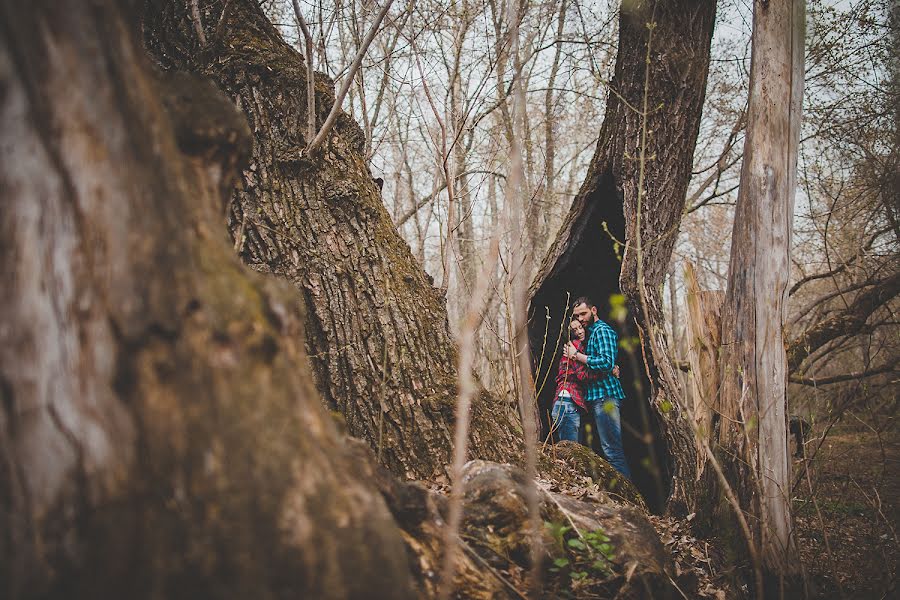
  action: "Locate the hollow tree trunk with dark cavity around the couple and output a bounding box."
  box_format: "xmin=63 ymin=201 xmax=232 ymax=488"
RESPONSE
xmin=531 ymin=0 xmax=715 ymax=511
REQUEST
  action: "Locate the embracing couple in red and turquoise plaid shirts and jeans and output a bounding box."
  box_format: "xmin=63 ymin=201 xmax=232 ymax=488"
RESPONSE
xmin=552 ymin=296 xmax=631 ymax=479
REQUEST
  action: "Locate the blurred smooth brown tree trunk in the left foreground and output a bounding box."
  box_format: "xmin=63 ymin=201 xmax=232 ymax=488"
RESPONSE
xmin=0 ymin=0 xmax=412 ymax=599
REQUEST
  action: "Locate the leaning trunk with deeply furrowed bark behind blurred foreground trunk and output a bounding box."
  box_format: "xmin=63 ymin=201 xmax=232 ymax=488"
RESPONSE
xmin=144 ymin=0 xmax=521 ymax=478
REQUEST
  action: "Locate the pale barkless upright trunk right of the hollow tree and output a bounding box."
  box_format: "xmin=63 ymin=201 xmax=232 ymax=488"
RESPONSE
xmin=718 ymin=0 xmax=805 ymax=591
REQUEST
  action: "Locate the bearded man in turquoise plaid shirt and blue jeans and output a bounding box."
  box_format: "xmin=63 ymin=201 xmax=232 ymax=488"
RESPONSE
xmin=564 ymin=296 xmax=631 ymax=479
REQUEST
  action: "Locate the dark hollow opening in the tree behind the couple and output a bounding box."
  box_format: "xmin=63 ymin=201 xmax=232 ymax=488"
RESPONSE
xmin=528 ymin=176 xmax=668 ymax=512
